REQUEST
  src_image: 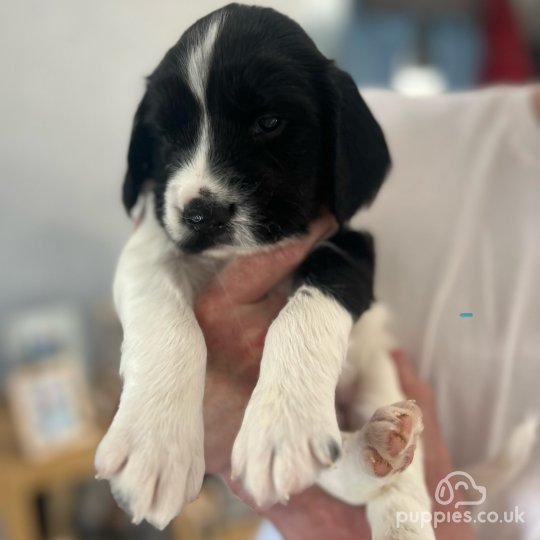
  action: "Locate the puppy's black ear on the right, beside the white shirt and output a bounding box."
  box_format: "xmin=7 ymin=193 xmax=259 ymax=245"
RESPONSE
xmin=322 ymin=66 xmax=391 ymax=223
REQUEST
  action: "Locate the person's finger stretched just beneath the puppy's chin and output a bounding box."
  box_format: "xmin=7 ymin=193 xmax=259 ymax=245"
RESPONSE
xmin=207 ymin=214 xmax=336 ymax=303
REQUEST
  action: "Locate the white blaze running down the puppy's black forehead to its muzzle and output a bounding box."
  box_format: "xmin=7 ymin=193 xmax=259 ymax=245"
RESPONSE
xmin=164 ymin=14 xmax=227 ymax=236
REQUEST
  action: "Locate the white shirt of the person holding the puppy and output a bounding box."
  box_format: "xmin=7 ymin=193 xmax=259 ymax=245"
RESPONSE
xmin=358 ymin=88 xmax=540 ymax=540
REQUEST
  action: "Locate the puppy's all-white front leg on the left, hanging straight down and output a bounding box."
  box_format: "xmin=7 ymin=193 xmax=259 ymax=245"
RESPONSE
xmin=96 ymin=200 xmax=206 ymax=528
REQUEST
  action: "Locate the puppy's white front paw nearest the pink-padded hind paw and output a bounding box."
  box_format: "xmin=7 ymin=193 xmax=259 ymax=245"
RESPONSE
xmin=232 ymin=392 xmax=341 ymax=506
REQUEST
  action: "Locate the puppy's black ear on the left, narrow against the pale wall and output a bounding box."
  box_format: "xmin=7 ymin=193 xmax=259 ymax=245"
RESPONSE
xmin=122 ymin=94 xmax=155 ymax=214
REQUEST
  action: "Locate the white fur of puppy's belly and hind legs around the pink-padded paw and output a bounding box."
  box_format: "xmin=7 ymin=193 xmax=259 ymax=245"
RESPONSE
xmin=318 ymin=304 xmax=435 ymax=540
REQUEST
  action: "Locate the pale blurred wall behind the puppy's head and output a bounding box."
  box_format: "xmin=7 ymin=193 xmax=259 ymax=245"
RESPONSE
xmin=0 ymin=0 xmax=335 ymax=317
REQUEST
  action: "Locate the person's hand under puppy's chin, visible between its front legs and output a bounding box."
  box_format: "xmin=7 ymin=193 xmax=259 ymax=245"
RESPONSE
xmin=195 ymin=216 xmax=335 ymax=474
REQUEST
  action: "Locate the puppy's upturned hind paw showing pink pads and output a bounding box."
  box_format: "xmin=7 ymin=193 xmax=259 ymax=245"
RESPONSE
xmin=364 ymin=401 xmax=424 ymax=476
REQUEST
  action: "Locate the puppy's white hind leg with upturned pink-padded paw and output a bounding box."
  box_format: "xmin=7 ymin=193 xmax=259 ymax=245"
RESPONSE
xmin=317 ymin=401 xmax=435 ymax=540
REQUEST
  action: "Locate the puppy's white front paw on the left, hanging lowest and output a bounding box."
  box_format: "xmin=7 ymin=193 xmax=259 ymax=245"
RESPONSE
xmin=95 ymin=405 xmax=204 ymax=529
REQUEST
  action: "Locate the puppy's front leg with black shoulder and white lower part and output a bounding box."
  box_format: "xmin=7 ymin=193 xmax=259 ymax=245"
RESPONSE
xmin=232 ymin=232 xmax=373 ymax=505
